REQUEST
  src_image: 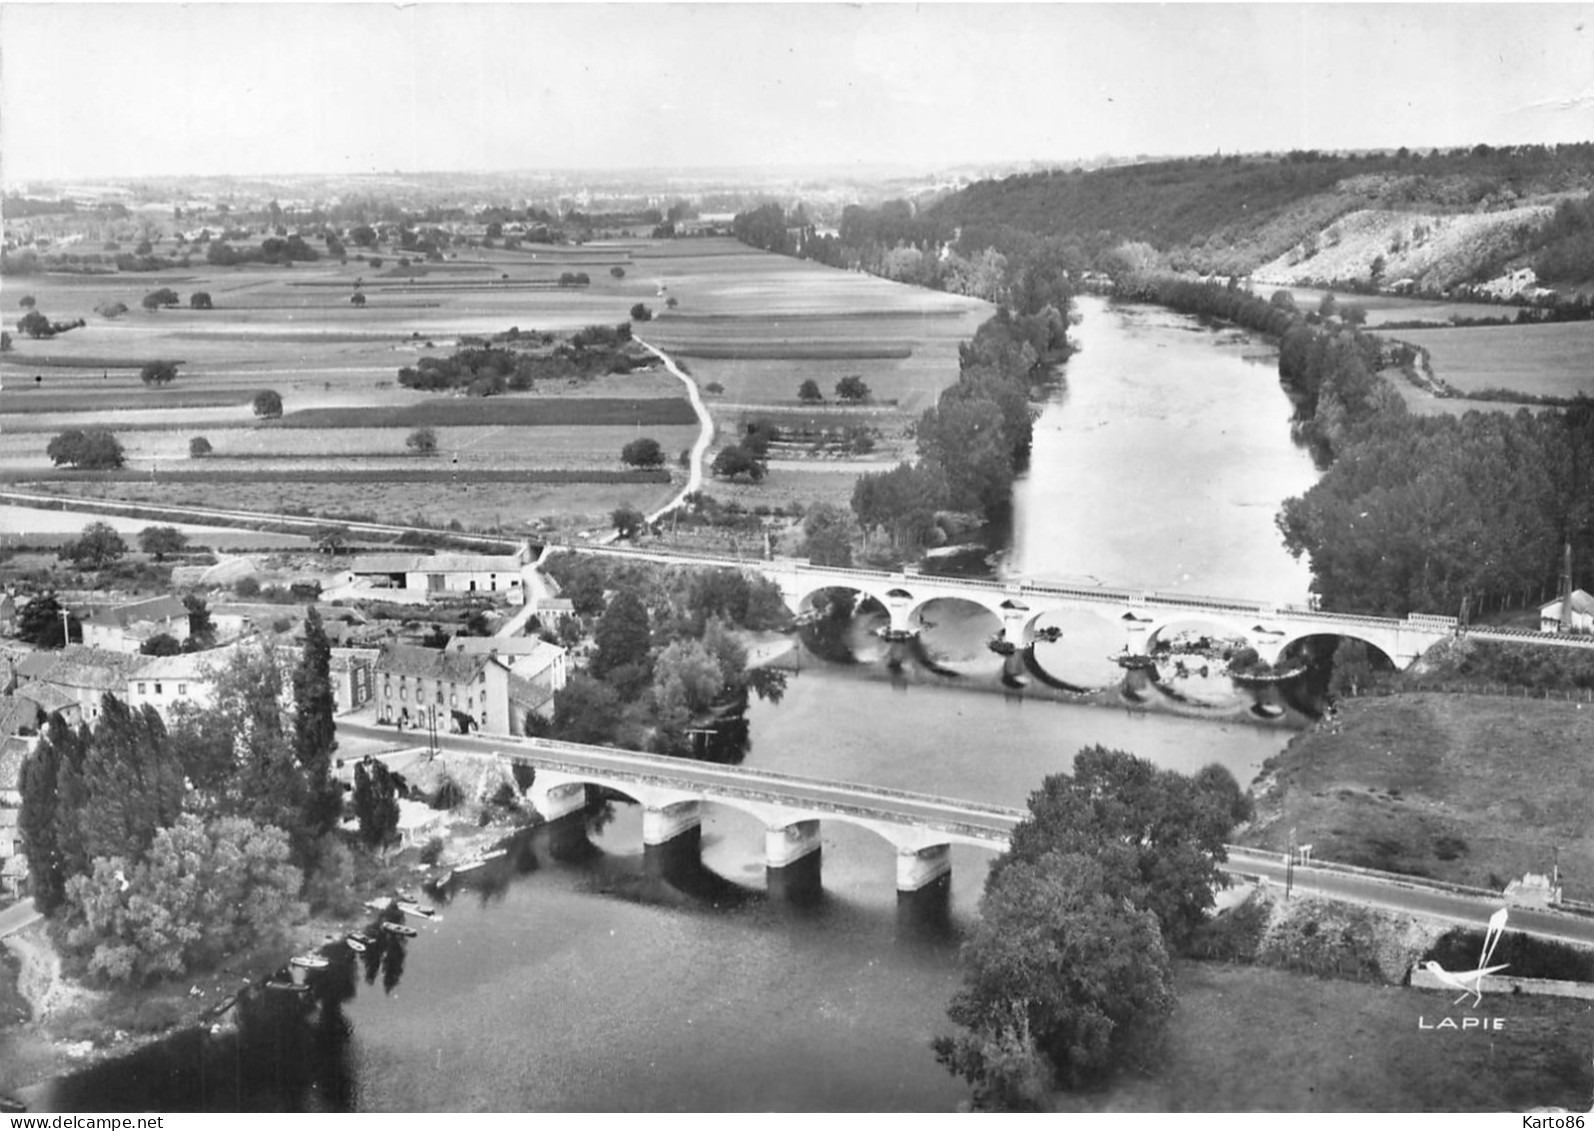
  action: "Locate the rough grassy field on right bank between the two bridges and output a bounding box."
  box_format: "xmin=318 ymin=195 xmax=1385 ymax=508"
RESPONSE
xmin=1239 ymin=693 xmax=1594 ymax=900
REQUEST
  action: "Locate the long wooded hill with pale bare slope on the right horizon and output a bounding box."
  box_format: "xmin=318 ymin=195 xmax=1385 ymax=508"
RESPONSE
xmin=923 ymin=143 xmax=1594 ymax=292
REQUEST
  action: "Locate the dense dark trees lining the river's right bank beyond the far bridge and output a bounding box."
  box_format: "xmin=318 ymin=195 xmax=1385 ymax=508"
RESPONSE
xmin=1132 ymin=279 xmax=1594 ymax=616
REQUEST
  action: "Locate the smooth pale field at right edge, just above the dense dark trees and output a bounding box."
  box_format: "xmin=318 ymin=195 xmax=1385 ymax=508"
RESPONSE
xmin=1393 ymin=322 xmax=1594 ymax=401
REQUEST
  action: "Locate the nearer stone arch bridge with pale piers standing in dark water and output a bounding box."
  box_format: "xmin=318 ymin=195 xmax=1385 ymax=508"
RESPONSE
xmin=424 ymin=734 xmax=1025 ymax=894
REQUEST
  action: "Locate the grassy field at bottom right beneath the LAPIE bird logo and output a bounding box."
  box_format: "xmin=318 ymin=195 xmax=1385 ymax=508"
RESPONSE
xmin=1063 ymin=962 xmax=1594 ymax=1112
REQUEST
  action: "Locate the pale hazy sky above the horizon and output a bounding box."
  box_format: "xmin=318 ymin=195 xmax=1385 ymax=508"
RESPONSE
xmin=0 ymin=2 xmax=1594 ymax=185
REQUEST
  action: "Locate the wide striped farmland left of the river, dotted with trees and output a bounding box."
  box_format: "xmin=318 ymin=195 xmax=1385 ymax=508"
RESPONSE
xmin=0 ymin=239 xmax=990 ymax=529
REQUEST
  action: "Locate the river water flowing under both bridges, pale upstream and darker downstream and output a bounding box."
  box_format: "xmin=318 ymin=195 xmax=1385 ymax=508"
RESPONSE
xmin=37 ymin=298 xmax=1313 ymax=1110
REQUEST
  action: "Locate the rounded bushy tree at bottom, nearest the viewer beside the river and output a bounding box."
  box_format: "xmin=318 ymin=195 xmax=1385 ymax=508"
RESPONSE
xmin=934 ymin=852 xmax=1173 ymax=1110
